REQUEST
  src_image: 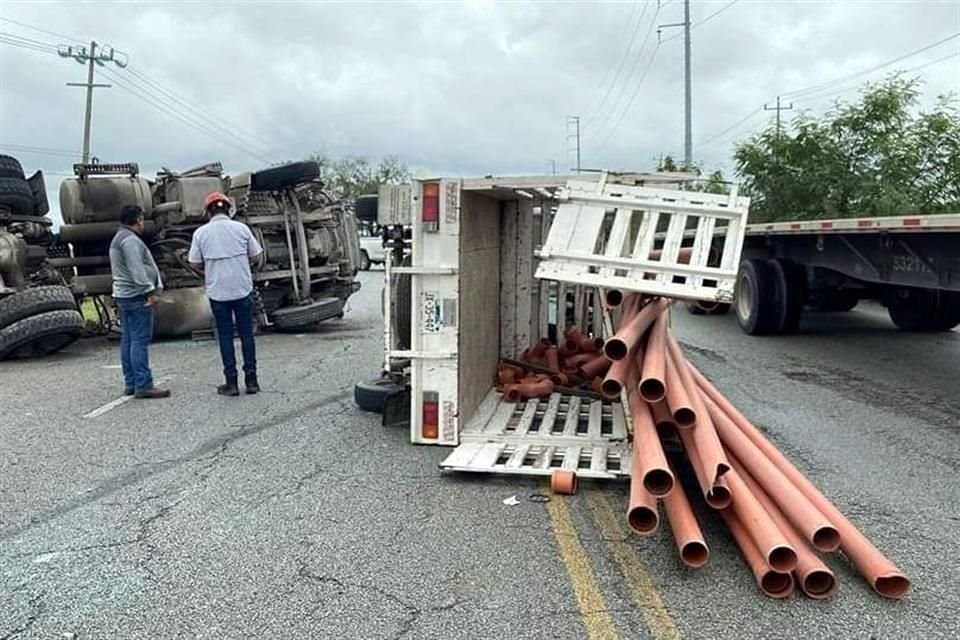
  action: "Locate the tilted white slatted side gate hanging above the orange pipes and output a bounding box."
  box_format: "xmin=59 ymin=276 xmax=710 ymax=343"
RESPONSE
xmin=536 ymin=179 xmax=750 ymax=302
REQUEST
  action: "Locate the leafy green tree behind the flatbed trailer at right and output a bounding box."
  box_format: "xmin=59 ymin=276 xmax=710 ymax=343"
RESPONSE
xmin=734 ymin=76 xmax=960 ymax=222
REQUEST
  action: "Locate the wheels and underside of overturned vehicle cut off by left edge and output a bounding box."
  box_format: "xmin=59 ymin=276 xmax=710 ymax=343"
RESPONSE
xmin=0 ymin=155 xmax=84 ymax=360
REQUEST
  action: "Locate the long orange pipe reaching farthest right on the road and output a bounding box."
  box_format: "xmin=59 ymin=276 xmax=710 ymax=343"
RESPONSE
xmin=691 ymin=367 xmax=910 ymax=598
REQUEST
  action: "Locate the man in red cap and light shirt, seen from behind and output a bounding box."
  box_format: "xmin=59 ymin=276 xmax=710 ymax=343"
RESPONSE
xmin=188 ymin=192 xmax=263 ymax=396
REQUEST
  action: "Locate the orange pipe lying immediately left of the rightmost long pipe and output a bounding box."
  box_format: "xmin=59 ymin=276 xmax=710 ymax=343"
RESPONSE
xmin=703 ymin=395 xmax=840 ymax=552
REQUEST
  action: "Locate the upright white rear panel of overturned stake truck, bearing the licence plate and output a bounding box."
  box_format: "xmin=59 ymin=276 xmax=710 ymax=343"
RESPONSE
xmin=408 ymin=180 xmax=460 ymax=445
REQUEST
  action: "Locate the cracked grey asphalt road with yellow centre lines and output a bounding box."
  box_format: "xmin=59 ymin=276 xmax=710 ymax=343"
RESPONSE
xmin=0 ymin=272 xmax=960 ymax=639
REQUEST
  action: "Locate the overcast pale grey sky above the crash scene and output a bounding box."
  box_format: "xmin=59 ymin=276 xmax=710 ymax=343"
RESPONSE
xmin=0 ymin=0 xmax=960 ymax=220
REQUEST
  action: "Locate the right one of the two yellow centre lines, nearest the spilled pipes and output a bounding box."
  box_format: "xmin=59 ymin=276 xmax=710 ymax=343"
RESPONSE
xmin=587 ymin=490 xmax=681 ymax=640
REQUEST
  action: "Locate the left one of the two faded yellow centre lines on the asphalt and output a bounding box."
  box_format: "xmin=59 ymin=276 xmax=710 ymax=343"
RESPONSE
xmin=544 ymin=483 xmax=618 ymax=640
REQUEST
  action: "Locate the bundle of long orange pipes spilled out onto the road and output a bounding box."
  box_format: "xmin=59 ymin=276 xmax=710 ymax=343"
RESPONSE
xmin=601 ymin=297 xmax=910 ymax=599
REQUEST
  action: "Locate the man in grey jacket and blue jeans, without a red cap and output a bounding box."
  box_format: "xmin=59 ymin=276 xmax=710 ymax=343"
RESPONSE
xmin=110 ymin=205 xmax=170 ymax=398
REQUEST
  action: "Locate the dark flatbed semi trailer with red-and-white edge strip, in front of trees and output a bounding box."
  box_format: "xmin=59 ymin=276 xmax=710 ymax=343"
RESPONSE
xmin=708 ymin=214 xmax=960 ymax=335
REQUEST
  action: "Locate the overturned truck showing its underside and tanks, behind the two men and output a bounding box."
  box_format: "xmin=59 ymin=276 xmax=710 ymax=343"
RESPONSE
xmin=57 ymin=162 xmax=360 ymax=336
